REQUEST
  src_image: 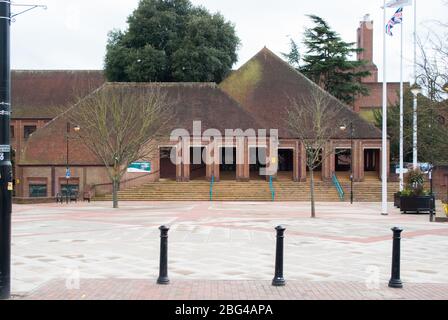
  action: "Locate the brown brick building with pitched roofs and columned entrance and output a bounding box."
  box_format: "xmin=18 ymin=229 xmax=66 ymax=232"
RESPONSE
xmin=13 ymin=48 xmax=388 ymax=198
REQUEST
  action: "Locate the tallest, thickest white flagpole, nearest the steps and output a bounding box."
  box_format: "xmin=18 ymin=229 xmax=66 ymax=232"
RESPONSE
xmin=381 ymin=0 xmax=388 ymax=215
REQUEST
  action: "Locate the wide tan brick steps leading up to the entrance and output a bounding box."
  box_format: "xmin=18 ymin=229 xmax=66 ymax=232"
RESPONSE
xmin=94 ymin=180 xmax=399 ymax=202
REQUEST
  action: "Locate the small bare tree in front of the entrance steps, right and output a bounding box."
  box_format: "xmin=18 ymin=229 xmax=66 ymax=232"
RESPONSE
xmin=287 ymin=87 xmax=346 ymax=218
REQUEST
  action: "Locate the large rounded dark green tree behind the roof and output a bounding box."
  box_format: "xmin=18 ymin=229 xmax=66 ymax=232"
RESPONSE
xmin=105 ymin=0 xmax=239 ymax=82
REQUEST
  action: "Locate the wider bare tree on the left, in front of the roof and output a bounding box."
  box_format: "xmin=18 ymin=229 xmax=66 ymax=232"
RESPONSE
xmin=64 ymin=84 xmax=172 ymax=208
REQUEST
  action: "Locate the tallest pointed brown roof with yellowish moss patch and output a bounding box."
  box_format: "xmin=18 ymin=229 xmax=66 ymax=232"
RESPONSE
xmin=219 ymin=47 xmax=381 ymax=139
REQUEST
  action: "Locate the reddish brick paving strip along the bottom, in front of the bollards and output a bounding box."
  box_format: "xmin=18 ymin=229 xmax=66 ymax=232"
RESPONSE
xmin=16 ymin=279 xmax=448 ymax=300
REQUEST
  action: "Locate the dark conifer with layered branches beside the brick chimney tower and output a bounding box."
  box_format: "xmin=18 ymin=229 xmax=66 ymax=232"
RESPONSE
xmin=284 ymin=15 xmax=370 ymax=104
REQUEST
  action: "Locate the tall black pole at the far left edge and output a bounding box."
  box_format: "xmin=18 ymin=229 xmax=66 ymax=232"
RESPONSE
xmin=0 ymin=0 xmax=12 ymax=299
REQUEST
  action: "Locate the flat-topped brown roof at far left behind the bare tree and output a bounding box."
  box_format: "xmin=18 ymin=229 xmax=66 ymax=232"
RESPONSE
xmin=11 ymin=70 xmax=105 ymax=119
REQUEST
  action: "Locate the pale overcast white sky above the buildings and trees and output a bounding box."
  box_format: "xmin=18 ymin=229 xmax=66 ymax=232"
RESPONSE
xmin=12 ymin=0 xmax=448 ymax=81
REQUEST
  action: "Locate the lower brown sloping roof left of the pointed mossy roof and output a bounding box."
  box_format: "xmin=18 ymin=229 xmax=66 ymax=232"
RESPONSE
xmin=20 ymin=83 xmax=258 ymax=165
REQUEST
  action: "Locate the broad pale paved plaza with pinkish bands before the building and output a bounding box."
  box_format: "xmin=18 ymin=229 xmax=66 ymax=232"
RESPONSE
xmin=12 ymin=202 xmax=448 ymax=299
